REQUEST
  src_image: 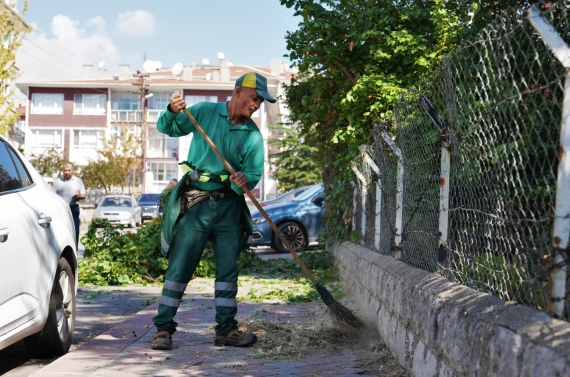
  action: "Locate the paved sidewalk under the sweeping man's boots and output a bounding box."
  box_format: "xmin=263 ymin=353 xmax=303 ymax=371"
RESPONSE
xmin=33 ymin=281 xmax=400 ymax=377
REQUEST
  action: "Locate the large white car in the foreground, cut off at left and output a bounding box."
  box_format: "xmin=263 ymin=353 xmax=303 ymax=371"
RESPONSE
xmin=0 ymin=137 xmax=77 ymax=358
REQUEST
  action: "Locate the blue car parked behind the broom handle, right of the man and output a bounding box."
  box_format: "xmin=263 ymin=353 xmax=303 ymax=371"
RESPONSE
xmin=251 ymin=184 xmax=325 ymax=253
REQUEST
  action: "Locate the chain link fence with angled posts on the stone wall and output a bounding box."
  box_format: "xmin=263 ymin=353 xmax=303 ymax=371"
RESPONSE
xmin=353 ymin=1 xmax=570 ymax=319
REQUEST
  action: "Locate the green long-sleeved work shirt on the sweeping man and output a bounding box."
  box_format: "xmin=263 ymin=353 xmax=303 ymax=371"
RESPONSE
xmin=156 ymin=102 xmax=265 ymax=195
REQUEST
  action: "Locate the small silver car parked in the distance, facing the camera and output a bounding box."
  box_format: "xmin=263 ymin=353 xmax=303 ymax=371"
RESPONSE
xmin=93 ymin=195 xmax=142 ymax=228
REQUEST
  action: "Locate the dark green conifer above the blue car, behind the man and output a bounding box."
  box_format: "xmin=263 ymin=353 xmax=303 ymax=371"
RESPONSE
xmin=268 ymin=125 xmax=321 ymax=192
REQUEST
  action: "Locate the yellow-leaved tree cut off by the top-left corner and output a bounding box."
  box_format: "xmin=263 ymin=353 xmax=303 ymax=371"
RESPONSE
xmin=0 ymin=1 xmax=30 ymax=135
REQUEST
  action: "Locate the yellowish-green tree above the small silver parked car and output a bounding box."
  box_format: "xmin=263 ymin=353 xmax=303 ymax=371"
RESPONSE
xmin=81 ymin=123 xmax=144 ymax=192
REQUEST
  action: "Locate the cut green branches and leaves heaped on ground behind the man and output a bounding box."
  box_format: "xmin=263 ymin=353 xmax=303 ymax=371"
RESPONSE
xmin=79 ymin=218 xmax=342 ymax=303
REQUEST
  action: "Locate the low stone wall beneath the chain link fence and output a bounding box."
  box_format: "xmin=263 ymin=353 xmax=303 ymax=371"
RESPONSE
xmin=328 ymin=242 xmax=570 ymax=377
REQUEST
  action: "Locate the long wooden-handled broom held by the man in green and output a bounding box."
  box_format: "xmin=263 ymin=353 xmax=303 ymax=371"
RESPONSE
xmin=183 ymin=108 xmax=366 ymax=332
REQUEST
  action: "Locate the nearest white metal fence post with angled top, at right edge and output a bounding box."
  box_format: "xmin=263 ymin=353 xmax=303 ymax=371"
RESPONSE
xmin=526 ymin=6 xmax=570 ymax=318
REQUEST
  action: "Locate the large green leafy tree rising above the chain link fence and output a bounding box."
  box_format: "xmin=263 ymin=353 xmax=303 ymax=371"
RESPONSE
xmin=281 ymin=0 xmax=529 ymax=237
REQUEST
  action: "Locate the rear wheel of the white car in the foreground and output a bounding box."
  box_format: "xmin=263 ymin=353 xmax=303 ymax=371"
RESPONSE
xmin=24 ymin=258 xmax=75 ymax=358
